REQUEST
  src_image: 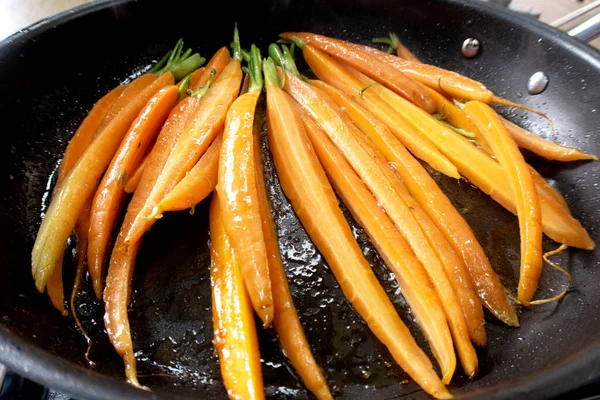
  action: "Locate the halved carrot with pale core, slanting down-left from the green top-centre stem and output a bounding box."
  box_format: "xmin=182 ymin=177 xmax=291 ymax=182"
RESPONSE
xmin=125 ymin=54 xmax=242 ymax=245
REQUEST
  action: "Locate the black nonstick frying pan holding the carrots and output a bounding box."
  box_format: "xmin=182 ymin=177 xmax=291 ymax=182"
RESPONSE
xmin=0 ymin=0 xmax=600 ymax=399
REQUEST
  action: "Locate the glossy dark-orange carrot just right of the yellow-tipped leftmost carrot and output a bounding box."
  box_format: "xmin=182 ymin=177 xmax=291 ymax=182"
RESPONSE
xmin=88 ymin=85 xmax=179 ymax=299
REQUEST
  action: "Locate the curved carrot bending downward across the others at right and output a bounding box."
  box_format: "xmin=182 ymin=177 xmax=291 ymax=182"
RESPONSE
xmin=464 ymin=101 xmax=542 ymax=306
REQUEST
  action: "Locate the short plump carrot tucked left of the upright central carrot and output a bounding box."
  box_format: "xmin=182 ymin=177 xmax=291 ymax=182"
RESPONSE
xmin=157 ymin=135 xmax=223 ymax=213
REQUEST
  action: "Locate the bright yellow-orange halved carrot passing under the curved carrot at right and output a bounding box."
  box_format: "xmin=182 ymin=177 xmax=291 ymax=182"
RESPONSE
xmin=346 ymin=60 xmax=594 ymax=249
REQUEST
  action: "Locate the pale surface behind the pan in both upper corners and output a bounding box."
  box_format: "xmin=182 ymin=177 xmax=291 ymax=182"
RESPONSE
xmin=0 ymin=0 xmax=600 ymax=43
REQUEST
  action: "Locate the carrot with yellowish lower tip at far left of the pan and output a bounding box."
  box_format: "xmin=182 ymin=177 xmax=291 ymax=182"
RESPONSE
xmin=32 ymin=73 xmax=173 ymax=292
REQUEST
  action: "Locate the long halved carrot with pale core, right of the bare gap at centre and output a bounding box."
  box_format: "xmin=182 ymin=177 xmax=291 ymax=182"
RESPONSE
xmin=264 ymin=60 xmax=451 ymax=398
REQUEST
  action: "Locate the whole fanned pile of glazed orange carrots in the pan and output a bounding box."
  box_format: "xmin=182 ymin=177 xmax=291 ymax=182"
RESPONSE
xmin=32 ymin=28 xmax=596 ymax=399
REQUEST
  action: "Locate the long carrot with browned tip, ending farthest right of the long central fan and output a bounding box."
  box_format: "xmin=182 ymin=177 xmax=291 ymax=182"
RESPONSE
xmin=311 ymin=81 xmax=519 ymax=326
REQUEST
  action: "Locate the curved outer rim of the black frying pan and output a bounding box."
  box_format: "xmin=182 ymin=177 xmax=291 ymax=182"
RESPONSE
xmin=0 ymin=0 xmax=600 ymax=400
